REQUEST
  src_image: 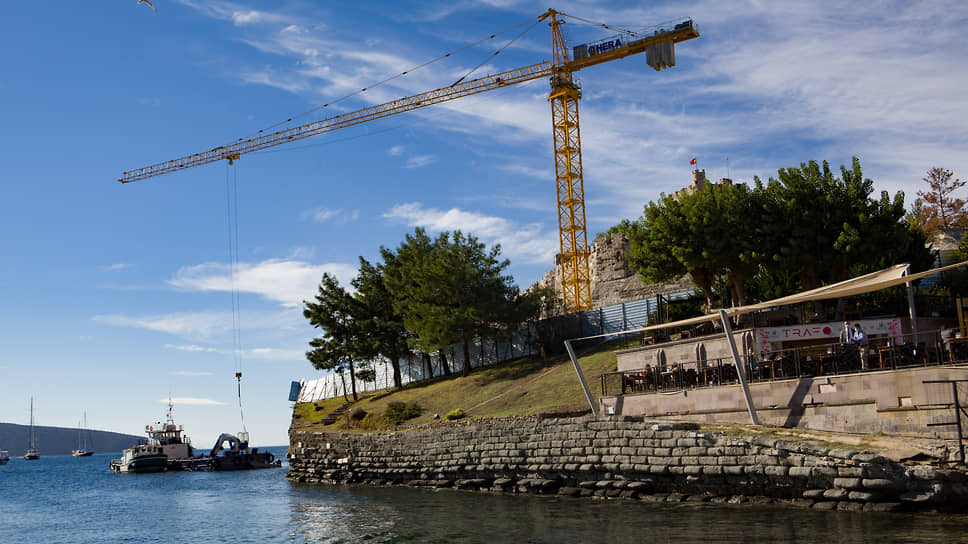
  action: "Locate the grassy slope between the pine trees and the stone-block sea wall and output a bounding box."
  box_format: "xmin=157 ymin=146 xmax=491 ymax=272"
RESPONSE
xmin=293 ymin=343 xmax=624 ymax=430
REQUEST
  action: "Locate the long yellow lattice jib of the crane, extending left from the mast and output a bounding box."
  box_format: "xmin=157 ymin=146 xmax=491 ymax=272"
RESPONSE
xmin=118 ymin=62 xmax=552 ymax=183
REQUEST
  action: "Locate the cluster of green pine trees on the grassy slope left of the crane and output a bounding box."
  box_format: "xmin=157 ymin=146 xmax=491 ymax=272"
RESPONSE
xmin=303 ymin=229 xmax=540 ymax=386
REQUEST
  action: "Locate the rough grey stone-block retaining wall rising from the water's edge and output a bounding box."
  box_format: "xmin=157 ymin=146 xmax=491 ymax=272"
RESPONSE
xmin=287 ymin=417 xmax=968 ymax=511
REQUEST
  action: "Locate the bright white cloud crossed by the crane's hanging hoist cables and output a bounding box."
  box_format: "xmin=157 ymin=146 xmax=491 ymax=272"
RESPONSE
xmin=168 ymin=259 xmax=356 ymax=307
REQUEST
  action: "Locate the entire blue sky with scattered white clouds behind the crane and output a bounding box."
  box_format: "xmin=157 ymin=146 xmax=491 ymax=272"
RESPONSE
xmin=0 ymin=0 xmax=968 ymax=449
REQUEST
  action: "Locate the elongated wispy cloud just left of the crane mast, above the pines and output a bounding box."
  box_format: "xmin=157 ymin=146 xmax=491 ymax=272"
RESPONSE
xmin=383 ymin=202 xmax=558 ymax=263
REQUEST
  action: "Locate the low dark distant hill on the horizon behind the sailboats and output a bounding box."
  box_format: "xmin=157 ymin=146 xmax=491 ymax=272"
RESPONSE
xmin=0 ymin=423 xmax=146 ymax=457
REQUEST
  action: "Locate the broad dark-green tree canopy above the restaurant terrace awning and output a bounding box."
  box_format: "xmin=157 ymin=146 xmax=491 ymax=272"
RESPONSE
xmin=617 ymin=157 xmax=931 ymax=308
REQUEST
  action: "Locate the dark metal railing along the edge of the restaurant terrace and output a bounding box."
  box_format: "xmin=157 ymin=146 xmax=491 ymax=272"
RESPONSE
xmin=601 ymin=331 xmax=956 ymax=396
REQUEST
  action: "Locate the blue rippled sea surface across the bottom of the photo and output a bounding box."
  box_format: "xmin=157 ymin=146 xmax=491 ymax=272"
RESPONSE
xmin=0 ymin=448 xmax=968 ymax=544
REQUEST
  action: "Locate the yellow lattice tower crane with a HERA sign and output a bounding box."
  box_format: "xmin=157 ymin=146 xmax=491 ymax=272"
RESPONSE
xmin=118 ymin=9 xmax=699 ymax=312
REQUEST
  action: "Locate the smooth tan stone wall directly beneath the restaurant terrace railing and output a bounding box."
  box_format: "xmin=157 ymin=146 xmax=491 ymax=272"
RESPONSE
xmin=601 ymin=365 xmax=968 ymax=437
